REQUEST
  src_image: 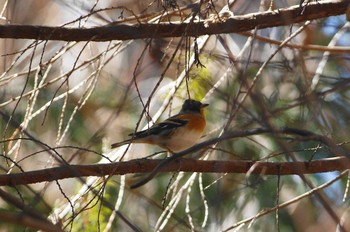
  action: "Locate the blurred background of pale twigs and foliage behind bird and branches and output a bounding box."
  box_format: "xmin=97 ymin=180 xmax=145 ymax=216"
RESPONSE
xmin=0 ymin=0 xmax=350 ymax=231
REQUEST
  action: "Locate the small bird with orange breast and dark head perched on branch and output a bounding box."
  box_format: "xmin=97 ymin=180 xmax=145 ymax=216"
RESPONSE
xmin=112 ymin=99 xmax=209 ymax=153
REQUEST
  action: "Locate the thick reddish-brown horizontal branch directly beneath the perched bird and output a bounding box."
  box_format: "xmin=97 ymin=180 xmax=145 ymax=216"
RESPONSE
xmin=0 ymin=157 xmax=350 ymax=186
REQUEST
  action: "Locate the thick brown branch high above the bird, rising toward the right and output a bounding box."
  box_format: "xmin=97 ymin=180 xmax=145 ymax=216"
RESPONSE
xmin=0 ymin=0 xmax=350 ymax=41
